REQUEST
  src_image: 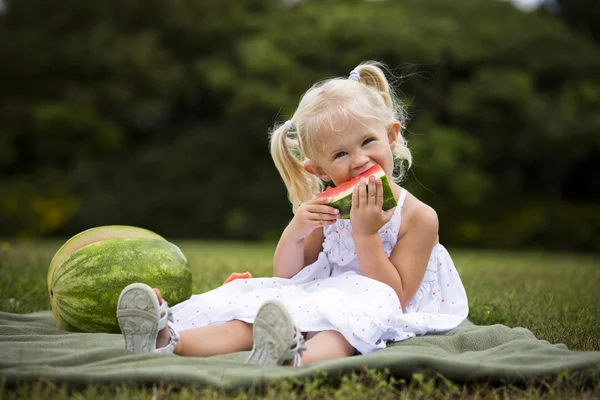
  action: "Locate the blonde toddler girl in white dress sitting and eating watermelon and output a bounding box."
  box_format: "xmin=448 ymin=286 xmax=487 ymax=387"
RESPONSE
xmin=117 ymin=62 xmax=468 ymax=366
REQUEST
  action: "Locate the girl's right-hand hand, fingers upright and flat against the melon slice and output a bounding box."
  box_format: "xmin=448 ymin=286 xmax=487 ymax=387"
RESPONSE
xmin=350 ymin=175 xmax=394 ymax=236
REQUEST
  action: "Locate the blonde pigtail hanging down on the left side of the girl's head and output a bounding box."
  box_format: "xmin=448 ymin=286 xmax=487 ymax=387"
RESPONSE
xmin=271 ymin=121 xmax=320 ymax=213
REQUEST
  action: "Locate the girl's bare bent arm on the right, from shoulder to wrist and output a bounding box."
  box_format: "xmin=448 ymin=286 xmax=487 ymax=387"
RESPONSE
xmin=354 ymin=203 xmax=438 ymax=308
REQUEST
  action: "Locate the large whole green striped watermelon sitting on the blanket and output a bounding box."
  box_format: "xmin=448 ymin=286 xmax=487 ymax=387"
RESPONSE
xmin=48 ymin=227 xmax=192 ymax=333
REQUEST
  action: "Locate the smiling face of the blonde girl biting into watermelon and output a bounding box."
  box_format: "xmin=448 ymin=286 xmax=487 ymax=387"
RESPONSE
xmin=305 ymin=118 xmax=400 ymax=186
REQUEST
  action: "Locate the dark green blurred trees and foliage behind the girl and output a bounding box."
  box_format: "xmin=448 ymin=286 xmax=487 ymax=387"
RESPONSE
xmin=0 ymin=0 xmax=600 ymax=252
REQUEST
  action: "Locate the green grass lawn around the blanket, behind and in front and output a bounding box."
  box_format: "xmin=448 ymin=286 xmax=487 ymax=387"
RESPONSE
xmin=0 ymin=241 xmax=600 ymax=399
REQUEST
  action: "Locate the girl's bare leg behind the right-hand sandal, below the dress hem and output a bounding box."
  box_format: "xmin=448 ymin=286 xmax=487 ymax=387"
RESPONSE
xmin=301 ymin=331 xmax=356 ymax=365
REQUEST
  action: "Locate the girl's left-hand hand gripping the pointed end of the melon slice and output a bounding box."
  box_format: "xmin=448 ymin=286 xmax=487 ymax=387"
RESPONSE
xmin=288 ymin=197 xmax=340 ymax=240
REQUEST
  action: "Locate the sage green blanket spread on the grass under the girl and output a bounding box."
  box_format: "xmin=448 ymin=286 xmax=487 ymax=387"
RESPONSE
xmin=0 ymin=311 xmax=600 ymax=389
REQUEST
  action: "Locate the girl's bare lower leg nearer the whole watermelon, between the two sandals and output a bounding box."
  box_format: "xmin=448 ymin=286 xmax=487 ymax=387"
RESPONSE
xmin=154 ymin=289 xmax=253 ymax=357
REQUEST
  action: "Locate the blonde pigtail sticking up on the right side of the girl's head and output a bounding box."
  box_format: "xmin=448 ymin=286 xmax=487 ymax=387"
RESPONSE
xmin=354 ymin=61 xmax=412 ymax=178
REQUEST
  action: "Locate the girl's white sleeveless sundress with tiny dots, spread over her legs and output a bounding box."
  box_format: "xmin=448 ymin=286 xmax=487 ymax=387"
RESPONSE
xmin=172 ymin=189 xmax=469 ymax=354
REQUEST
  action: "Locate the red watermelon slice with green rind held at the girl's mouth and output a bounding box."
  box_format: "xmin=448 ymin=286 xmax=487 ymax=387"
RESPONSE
xmin=317 ymin=165 xmax=398 ymax=219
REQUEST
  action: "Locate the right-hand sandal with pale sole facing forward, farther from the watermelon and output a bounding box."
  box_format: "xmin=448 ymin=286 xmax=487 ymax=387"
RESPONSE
xmin=246 ymin=300 xmax=306 ymax=367
